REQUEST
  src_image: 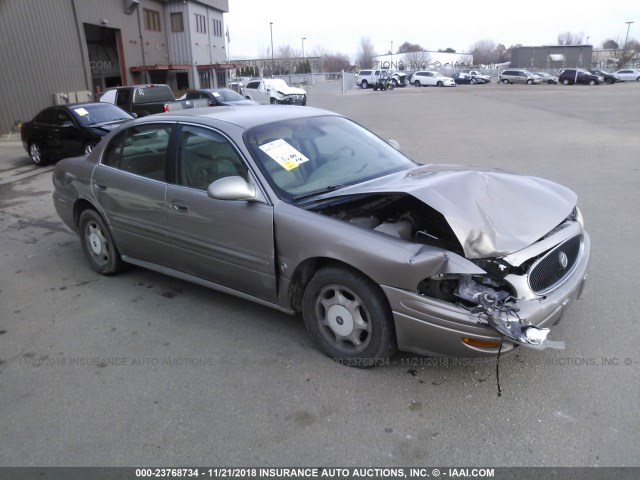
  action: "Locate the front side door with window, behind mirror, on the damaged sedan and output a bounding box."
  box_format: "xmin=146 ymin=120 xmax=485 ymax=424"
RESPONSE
xmin=166 ymin=125 xmax=276 ymax=301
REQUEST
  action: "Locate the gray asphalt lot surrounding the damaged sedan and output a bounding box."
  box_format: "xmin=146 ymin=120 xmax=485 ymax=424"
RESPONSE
xmin=0 ymin=82 xmax=640 ymax=467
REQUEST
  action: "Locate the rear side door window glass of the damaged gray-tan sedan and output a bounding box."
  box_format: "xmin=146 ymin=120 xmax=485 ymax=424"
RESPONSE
xmin=102 ymin=124 xmax=173 ymax=181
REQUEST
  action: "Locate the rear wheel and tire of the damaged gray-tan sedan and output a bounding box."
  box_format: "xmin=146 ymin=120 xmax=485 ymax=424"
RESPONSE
xmin=78 ymin=209 xmax=124 ymax=275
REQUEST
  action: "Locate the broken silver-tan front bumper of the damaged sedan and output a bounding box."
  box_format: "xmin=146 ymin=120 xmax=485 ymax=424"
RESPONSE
xmin=382 ymin=232 xmax=590 ymax=357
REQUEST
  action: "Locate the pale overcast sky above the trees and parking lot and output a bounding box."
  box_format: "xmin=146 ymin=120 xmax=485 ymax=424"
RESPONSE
xmin=225 ymin=0 xmax=640 ymax=61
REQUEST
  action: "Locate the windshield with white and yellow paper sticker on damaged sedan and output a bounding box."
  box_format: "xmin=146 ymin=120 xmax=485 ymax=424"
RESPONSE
xmin=244 ymin=116 xmax=416 ymax=202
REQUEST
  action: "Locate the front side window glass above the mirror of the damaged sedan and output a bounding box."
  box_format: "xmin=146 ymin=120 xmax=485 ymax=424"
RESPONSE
xmin=177 ymin=126 xmax=248 ymax=190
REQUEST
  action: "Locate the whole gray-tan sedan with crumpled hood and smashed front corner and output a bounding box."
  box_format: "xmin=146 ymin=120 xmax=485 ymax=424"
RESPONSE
xmin=53 ymin=106 xmax=590 ymax=367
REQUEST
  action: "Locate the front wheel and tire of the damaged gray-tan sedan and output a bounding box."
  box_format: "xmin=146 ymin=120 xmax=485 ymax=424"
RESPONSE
xmin=302 ymin=267 xmax=397 ymax=368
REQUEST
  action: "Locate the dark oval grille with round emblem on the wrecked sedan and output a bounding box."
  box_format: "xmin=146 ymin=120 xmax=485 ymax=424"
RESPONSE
xmin=529 ymin=235 xmax=582 ymax=294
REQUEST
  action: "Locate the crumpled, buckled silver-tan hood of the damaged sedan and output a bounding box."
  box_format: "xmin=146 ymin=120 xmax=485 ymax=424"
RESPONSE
xmin=325 ymin=165 xmax=577 ymax=259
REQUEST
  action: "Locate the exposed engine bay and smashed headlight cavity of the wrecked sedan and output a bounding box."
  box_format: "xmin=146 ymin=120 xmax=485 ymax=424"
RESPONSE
xmin=311 ymin=193 xmax=570 ymax=349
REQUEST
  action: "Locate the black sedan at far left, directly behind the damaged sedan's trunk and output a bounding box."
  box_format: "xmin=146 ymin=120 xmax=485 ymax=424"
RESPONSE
xmin=21 ymin=103 xmax=134 ymax=165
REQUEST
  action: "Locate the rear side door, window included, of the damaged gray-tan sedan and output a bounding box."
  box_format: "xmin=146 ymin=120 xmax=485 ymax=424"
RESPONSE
xmin=91 ymin=122 xmax=175 ymax=267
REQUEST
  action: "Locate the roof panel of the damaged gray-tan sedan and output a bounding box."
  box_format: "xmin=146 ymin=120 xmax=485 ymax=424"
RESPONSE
xmin=138 ymin=105 xmax=338 ymax=129
